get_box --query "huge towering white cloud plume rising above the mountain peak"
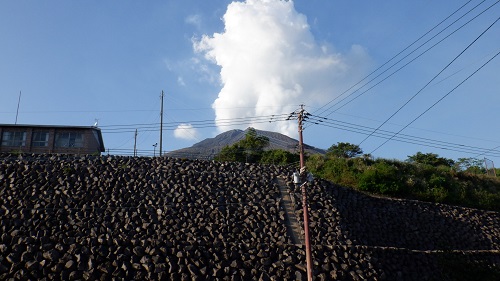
[193,0,368,136]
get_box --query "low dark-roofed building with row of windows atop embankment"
[0,124,105,154]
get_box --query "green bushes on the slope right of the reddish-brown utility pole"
[306,144,500,211]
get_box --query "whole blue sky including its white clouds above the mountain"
[0,0,500,166]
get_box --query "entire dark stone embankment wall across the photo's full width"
[0,155,500,280]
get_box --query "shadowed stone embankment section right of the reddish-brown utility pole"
[288,176,500,280]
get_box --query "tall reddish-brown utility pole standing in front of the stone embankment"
[298,105,312,281]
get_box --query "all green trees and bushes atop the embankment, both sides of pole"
[215,133,500,211]
